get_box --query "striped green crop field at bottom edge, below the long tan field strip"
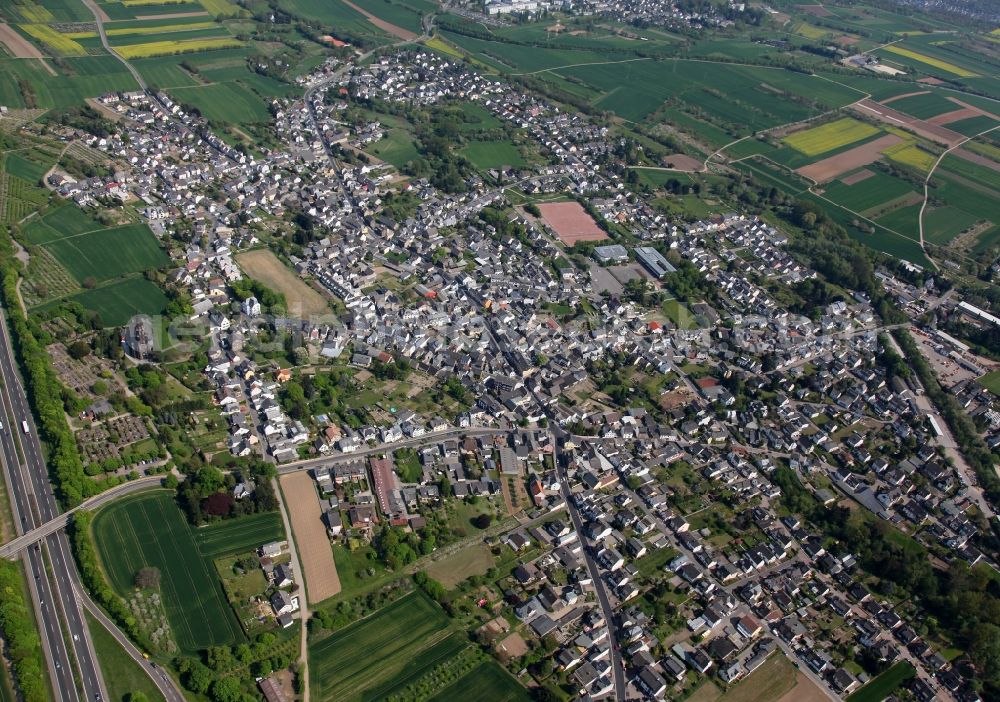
[309,592,478,702]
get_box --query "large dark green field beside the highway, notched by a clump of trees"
[93,490,243,652]
